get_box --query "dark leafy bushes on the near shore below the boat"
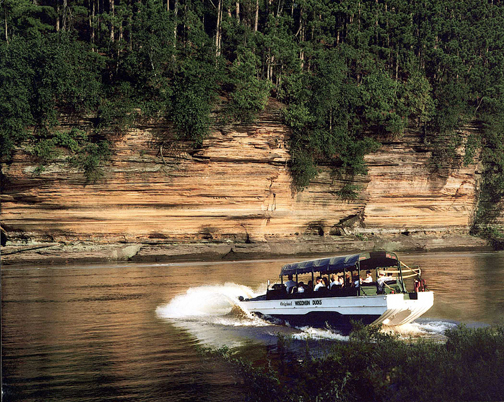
[207,326,504,402]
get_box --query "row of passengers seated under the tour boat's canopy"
[285,271,393,293]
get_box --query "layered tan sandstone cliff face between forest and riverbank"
[2,101,488,264]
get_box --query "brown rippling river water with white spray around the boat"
[2,252,504,401]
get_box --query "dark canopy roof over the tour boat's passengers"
[280,251,399,276]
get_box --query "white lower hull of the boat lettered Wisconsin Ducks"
[239,292,434,326]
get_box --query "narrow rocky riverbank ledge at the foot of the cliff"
[1,232,491,265]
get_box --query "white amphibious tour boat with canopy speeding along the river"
[238,251,434,328]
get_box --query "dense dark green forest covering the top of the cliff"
[0,0,504,236]
